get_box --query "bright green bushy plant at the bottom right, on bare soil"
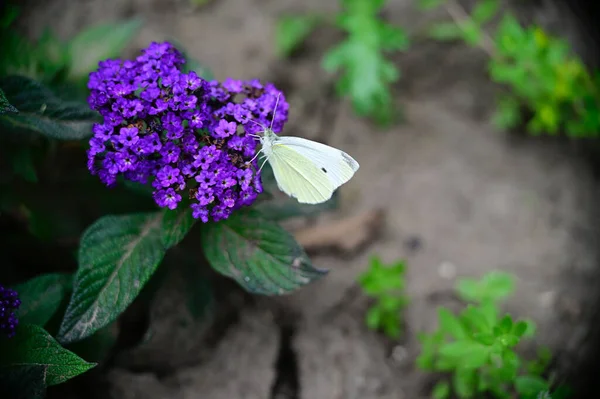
[417,273,551,399]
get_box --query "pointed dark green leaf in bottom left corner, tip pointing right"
[0,324,95,385]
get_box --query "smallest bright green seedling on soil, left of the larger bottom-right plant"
[358,257,408,339]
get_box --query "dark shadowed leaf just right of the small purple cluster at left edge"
[15,273,73,327]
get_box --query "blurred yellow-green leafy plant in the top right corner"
[420,0,600,137]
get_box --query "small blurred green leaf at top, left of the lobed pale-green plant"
[275,15,321,57]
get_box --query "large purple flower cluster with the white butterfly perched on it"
[88,42,288,223]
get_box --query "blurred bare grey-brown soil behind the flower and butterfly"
[17,0,598,399]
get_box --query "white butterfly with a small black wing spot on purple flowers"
[247,97,359,204]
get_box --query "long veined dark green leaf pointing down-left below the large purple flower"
[58,212,166,343]
